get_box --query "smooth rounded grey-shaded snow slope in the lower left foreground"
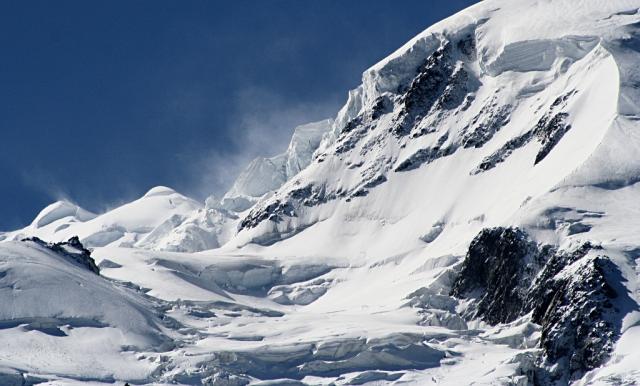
[0,241,173,385]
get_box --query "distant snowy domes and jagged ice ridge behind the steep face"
[5,119,333,252]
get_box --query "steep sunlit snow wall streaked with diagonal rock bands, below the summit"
[237,7,623,253]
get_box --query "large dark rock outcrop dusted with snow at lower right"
[451,228,619,385]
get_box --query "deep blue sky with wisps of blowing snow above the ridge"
[0,0,473,230]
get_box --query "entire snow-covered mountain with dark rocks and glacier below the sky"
[0,0,640,385]
